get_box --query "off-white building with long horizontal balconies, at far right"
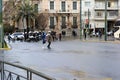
[94,0,120,31]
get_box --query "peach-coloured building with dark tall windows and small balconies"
[36,0,80,34]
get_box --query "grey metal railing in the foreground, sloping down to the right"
[0,61,55,80]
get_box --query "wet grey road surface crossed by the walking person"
[0,40,120,80]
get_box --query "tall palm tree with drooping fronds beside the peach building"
[16,0,36,39]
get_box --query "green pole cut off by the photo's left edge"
[0,0,4,48]
